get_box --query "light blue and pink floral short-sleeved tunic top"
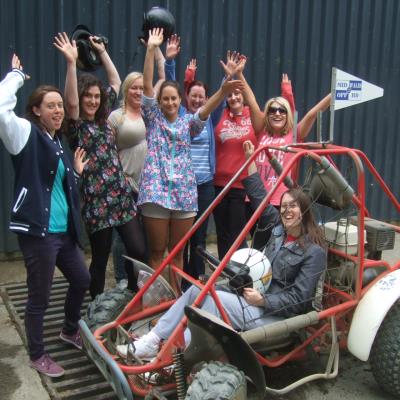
[138,96,206,211]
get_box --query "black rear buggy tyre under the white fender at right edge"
[370,300,400,398]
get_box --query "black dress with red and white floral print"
[69,87,136,234]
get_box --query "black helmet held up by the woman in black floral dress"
[71,25,108,72]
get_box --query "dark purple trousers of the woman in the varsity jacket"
[18,234,90,360]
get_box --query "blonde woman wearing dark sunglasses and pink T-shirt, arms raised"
[237,60,331,206]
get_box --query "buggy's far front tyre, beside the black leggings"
[83,287,135,332]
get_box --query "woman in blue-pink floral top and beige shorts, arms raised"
[138,29,242,293]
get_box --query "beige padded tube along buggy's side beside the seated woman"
[240,311,319,344]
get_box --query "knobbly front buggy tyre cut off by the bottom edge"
[185,361,247,400]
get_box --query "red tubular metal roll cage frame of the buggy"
[86,143,400,396]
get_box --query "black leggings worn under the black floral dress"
[89,217,146,299]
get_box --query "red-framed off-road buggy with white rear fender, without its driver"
[81,143,400,399]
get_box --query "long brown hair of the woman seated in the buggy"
[279,188,326,248]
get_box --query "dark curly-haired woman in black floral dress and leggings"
[54,33,145,298]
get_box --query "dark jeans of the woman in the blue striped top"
[182,180,215,290]
